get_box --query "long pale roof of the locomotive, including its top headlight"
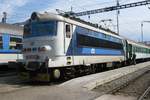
[31,12,122,39]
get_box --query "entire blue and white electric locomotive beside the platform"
[19,13,150,81]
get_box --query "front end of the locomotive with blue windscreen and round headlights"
[22,13,57,81]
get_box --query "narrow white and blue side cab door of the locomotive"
[65,23,74,64]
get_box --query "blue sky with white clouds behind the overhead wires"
[0,0,150,41]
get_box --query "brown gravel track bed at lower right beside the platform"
[94,68,150,100]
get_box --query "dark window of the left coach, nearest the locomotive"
[9,37,22,50]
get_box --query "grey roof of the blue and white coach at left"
[0,23,23,35]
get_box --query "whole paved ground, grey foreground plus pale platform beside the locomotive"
[0,62,150,100]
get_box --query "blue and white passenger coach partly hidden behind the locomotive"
[0,23,23,65]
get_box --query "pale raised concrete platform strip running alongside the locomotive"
[59,62,150,91]
